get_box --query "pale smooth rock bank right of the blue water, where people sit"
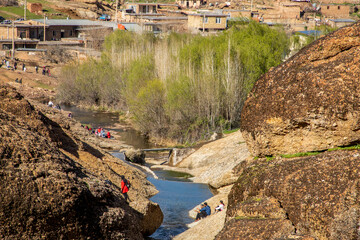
[148,131,250,240]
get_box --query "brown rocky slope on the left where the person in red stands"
[0,85,163,239]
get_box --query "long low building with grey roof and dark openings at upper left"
[0,19,121,50]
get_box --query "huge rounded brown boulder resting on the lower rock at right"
[241,23,360,156]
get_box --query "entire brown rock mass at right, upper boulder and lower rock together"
[216,23,360,240]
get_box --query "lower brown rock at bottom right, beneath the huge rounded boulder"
[216,150,360,240]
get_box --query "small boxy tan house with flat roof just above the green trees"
[188,13,229,32]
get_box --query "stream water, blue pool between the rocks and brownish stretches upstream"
[61,106,213,240]
